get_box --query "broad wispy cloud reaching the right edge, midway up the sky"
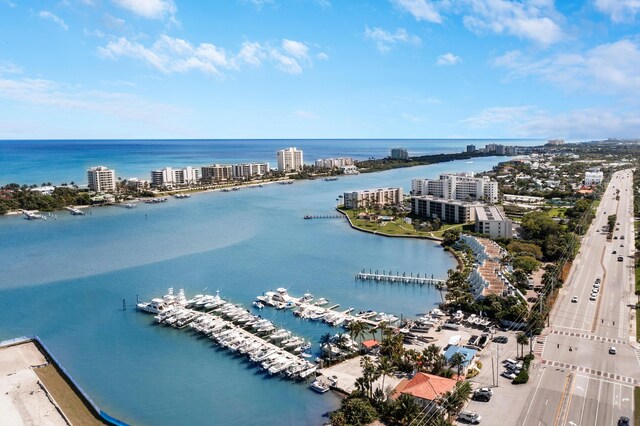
[494,39,640,95]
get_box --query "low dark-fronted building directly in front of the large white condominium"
[411,195,479,223]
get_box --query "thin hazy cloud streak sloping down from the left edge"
[0,74,178,128]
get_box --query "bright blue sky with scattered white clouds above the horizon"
[0,0,640,140]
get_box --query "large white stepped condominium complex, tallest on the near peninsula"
[411,173,498,203]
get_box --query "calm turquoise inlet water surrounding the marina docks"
[0,140,520,425]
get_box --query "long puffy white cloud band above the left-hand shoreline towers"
[98,35,320,76]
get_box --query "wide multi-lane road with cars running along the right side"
[518,171,640,426]
